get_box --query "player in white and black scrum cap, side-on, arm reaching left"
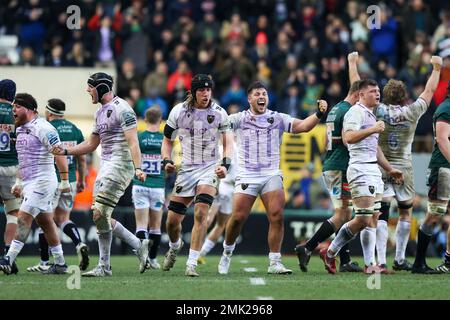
[53,72,149,277]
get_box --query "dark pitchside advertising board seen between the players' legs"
[0,208,370,255]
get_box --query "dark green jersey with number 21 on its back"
[133,131,165,188]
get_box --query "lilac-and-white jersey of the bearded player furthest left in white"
[16,117,61,182]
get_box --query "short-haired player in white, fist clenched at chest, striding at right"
[320,79,403,274]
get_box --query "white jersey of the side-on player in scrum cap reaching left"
[92,97,137,161]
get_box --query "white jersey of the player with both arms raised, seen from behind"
[374,98,428,166]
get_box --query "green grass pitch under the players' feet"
[0,255,450,300]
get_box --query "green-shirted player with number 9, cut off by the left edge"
[0,79,20,273]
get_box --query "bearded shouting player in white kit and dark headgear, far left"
[0,93,70,274]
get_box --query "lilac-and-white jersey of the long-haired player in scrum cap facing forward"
[167,102,230,169]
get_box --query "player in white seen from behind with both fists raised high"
[350,52,442,271]
